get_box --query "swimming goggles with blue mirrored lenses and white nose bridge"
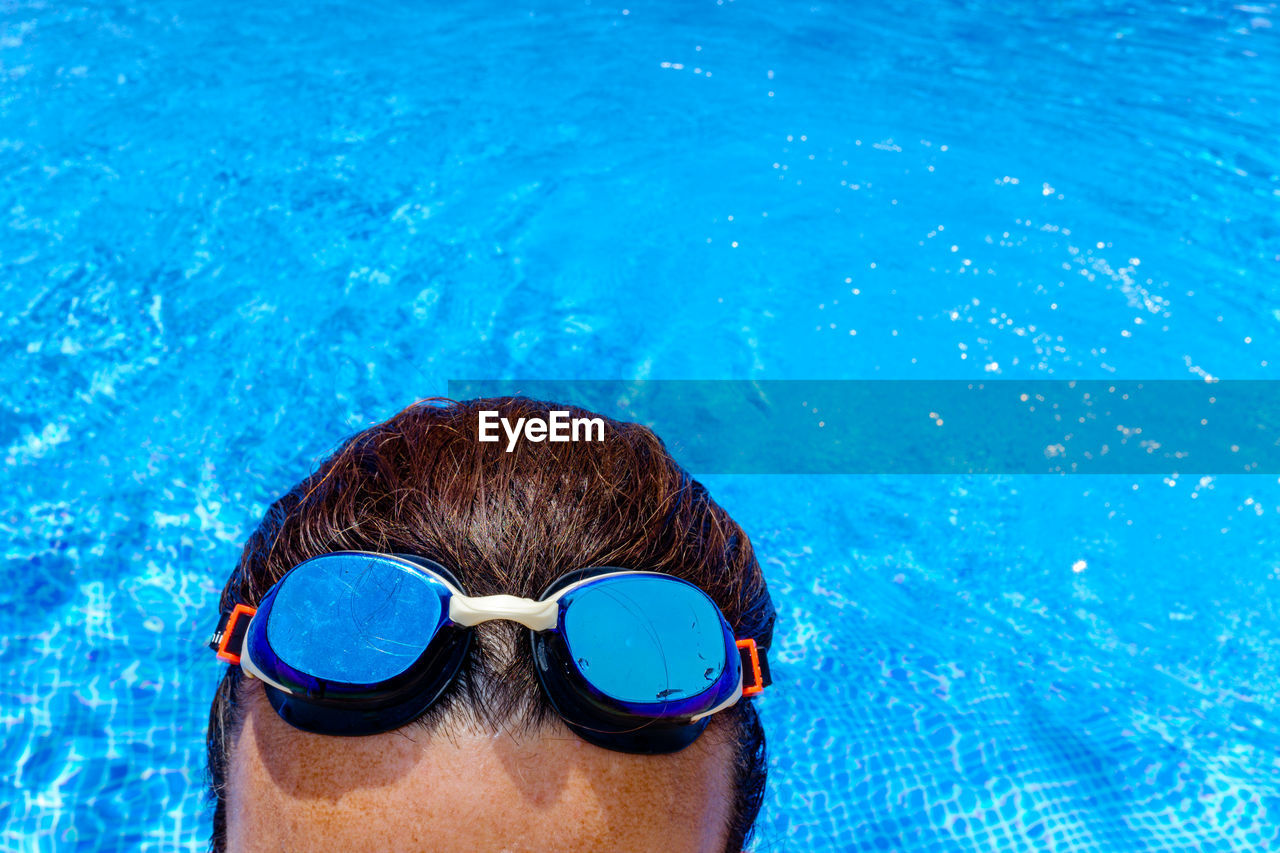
[209,551,772,753]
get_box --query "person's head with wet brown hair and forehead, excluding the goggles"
[207,398,772,853]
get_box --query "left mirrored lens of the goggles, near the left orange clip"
[266,555,442,684]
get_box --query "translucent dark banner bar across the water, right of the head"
[449,379,1280,475]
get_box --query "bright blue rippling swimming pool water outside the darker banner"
[0,0,1280,853]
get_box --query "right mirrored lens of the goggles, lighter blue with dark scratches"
[564,576,726,704]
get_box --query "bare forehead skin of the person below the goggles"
[227,681,733,853]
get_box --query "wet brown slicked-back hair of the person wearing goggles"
[206,397,772,853]
